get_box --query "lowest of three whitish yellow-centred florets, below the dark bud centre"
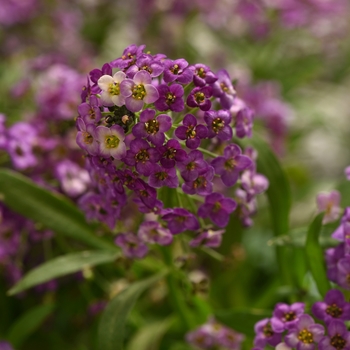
[95,125,126,159]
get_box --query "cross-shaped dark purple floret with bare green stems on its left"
[175,114,208,149]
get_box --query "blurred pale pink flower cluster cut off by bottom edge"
[186,318,244,350]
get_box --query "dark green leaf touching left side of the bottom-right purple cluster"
[215,309,272,336]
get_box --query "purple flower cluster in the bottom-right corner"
[254,289,350,350]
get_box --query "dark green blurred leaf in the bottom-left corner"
[7,304,54,349]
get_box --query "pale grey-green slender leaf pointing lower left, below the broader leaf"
[8,250,119,295]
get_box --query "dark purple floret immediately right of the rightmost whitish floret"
[154,84,185,112]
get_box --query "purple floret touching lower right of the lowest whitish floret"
[124,139,160,176]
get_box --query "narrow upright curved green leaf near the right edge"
[305,213,331,297]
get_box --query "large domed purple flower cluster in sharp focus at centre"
[76,45,268,257]
